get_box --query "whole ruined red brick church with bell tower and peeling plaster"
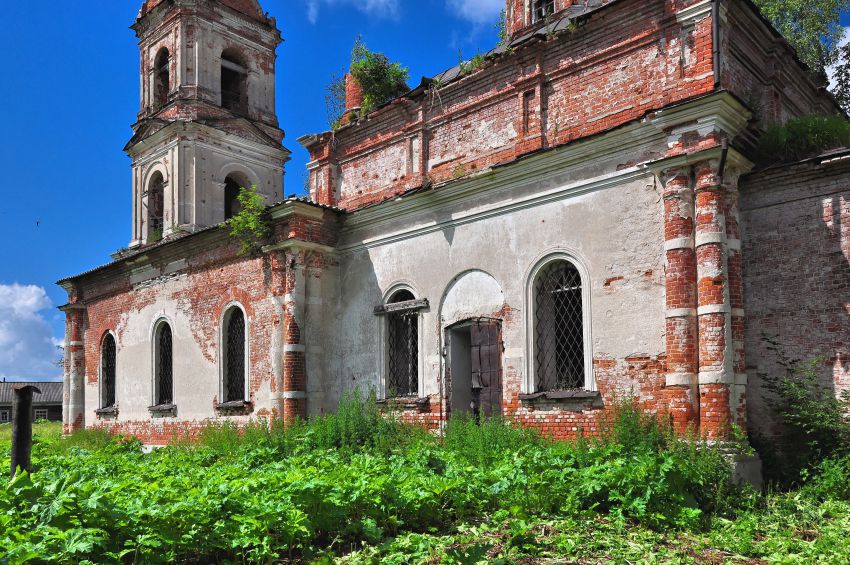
[59,0,850,454]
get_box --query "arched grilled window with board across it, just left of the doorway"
[387,290,419,397]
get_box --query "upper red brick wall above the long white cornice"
[306,0,716,209]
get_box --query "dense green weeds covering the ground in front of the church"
[0,395,850,563]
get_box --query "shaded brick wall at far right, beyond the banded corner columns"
[741,156,850,435]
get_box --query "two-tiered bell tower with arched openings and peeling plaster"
[124,0,290,247]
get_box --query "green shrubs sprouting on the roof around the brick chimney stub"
[325,37,410,130]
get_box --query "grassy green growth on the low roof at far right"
[758,116,850,164]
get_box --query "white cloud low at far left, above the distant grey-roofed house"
[0,284,62,380]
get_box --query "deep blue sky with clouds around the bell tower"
[0,0,503,380]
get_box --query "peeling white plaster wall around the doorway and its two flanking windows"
[314,163,665,409]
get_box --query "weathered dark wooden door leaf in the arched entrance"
[470,320,502,418]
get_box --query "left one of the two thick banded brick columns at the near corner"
[660,167,699,434]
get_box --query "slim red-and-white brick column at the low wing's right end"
[282,249,307,423]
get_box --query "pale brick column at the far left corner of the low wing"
[61,305,86,434]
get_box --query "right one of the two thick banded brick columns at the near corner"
[695,159,734,440]
